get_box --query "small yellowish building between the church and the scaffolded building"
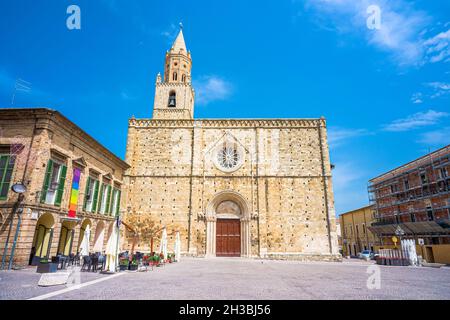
[339,205,379,256]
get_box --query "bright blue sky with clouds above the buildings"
[0,0,450,214]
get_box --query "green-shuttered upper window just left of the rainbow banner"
[41,159,67,206]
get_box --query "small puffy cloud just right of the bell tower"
[194,75,232,105]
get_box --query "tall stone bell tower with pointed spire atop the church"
[153,24,195,119]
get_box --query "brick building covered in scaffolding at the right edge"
[369,146,450,263]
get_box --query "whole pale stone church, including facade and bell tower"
[122,30,340,260]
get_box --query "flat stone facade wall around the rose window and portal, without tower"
[125,119,338,258]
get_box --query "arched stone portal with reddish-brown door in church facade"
[205,191,251,257]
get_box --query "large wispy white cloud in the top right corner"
[300,0,450,65]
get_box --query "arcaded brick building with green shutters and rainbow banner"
[0,108,129,265]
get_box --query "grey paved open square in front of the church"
[0,258,450,300]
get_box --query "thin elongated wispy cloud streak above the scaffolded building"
[384,110,449,132]
